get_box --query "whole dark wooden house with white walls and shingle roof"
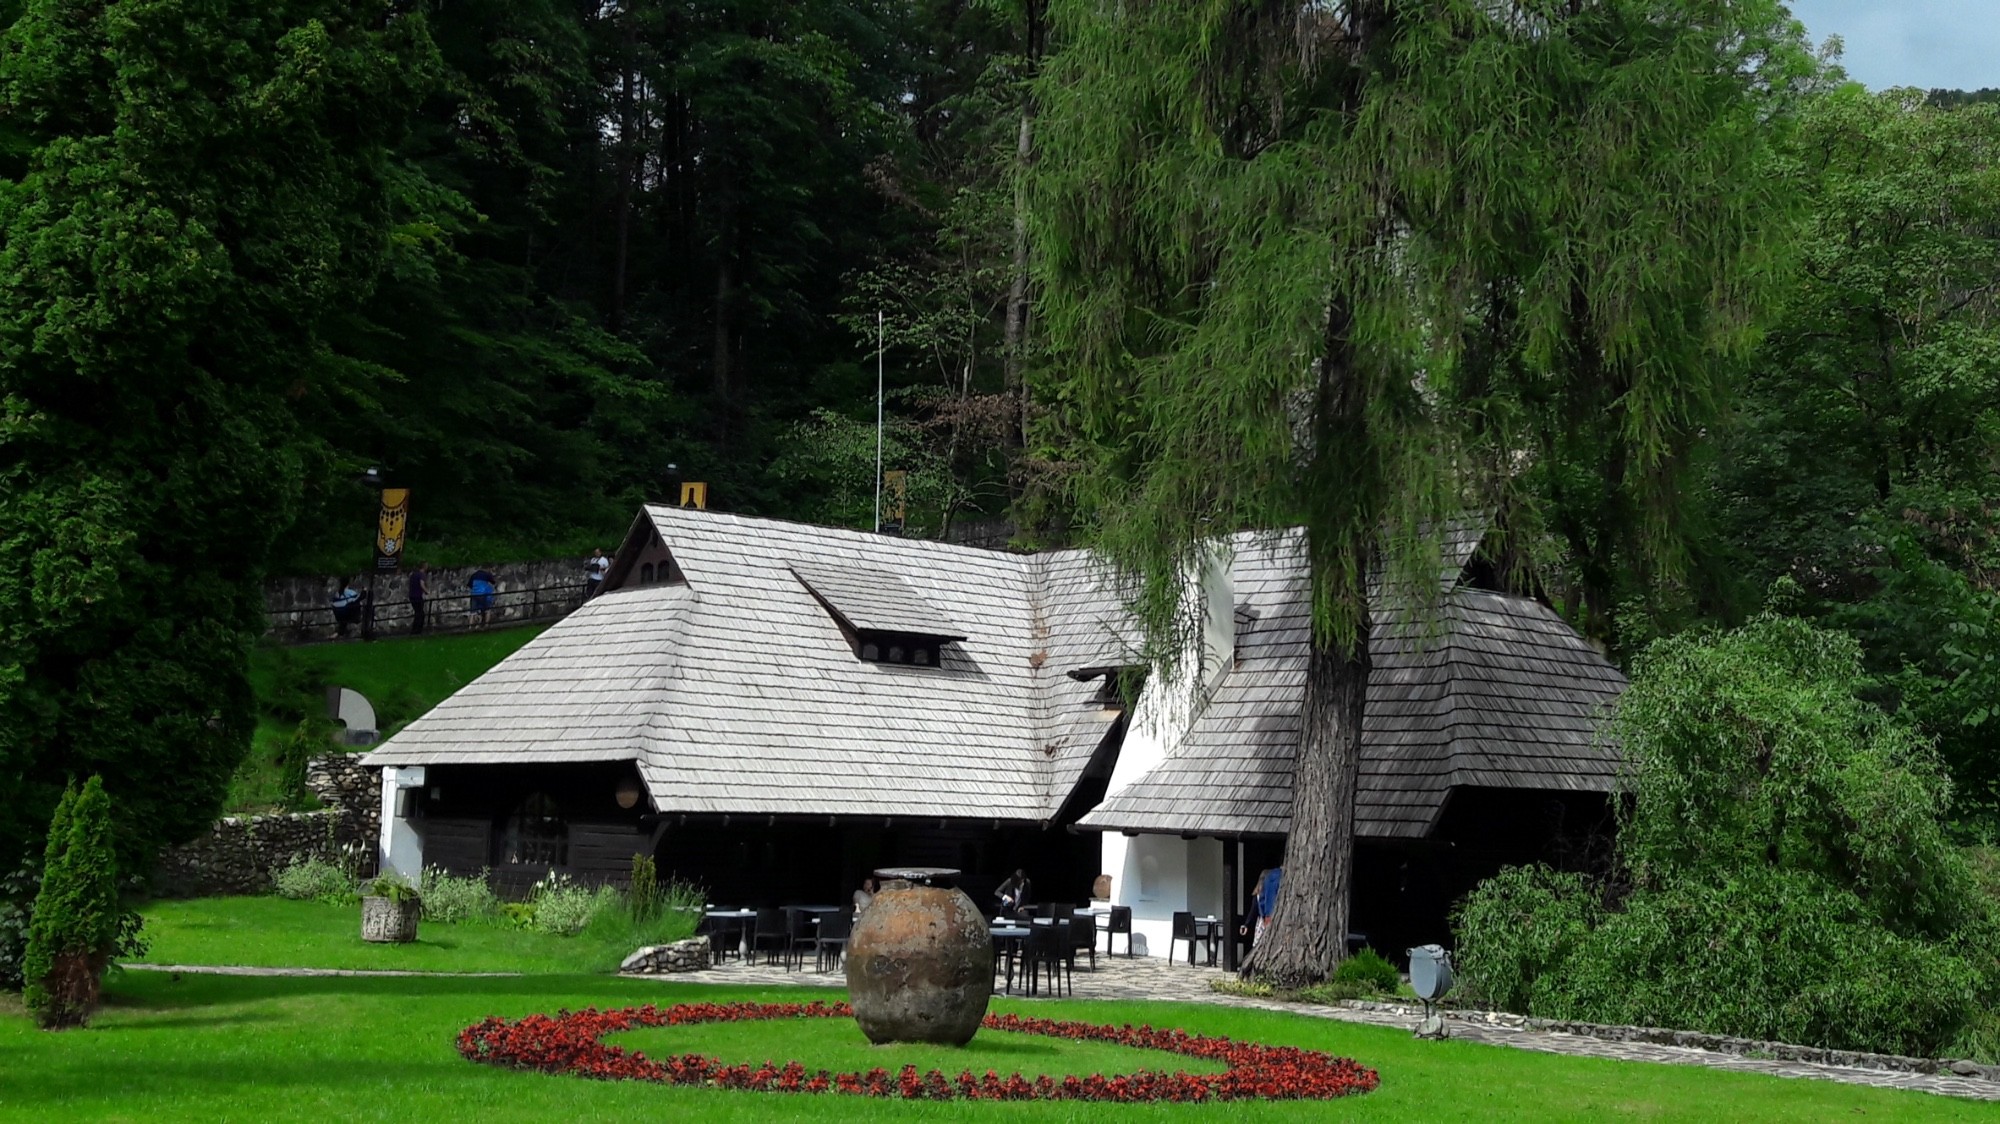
[368,506,1624,952]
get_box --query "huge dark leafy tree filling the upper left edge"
[0,0,434,870]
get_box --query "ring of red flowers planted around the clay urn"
[458,1002,1380,1100]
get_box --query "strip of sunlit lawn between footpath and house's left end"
[144,898,664,972]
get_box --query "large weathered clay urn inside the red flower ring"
[846,870,994,1046]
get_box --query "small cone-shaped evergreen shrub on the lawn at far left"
[22,776,122,1030]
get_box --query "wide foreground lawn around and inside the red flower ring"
[0,972,1994,1124]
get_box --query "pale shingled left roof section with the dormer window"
[368,506,1126,822]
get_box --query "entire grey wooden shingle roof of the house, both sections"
[368,506,1624,836]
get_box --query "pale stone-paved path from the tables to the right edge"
[642,956,2000,1102]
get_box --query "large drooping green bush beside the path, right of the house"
[1456,616,2000,1056]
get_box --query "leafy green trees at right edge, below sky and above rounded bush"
[1710,86,2000,836]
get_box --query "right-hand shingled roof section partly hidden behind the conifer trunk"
[1080,526,1626,838]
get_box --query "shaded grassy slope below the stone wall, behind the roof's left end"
[228,624,546,812]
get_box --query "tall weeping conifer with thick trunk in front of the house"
[1028,0,1810,984]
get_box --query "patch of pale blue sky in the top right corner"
[1790,0,2000,90]
